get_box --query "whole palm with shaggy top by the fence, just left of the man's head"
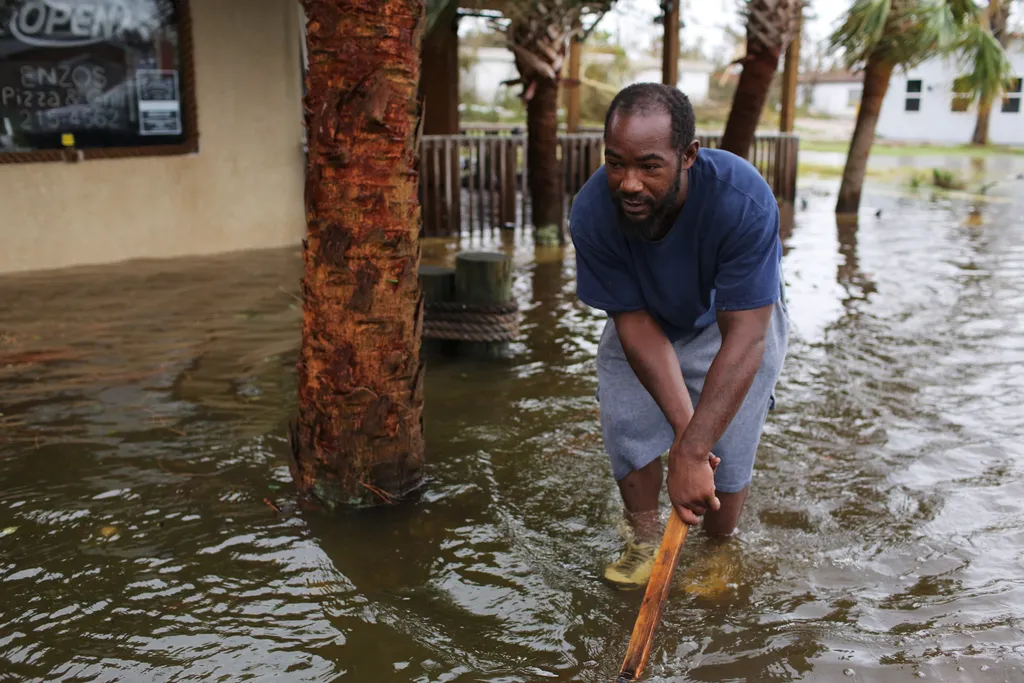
[492,0,613,244]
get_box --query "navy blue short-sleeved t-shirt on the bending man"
[569,148,782,341]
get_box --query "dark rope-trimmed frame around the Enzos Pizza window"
[0,0,199,165]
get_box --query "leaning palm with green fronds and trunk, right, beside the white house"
[830,0,1009,213]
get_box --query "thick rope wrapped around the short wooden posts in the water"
[423,301,519,342]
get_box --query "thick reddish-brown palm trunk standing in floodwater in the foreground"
[291,0,424,509]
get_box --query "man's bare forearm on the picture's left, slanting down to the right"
[613,311,693,437]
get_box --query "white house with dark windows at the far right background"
[877,42,1024,145]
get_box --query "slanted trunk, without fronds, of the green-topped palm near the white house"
[836,52,893,213]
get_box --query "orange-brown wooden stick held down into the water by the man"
[615,509,689,683]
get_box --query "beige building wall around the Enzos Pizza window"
[0,0,305,272]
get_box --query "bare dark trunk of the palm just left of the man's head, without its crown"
[526,79,565,244]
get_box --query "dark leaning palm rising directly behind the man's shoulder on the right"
[721,0,803,157]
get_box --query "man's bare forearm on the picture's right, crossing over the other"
[680,309,765,459]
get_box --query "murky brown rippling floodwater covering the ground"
[0,162,1024,683]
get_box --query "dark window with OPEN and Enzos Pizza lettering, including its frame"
[0,0,199,163]
